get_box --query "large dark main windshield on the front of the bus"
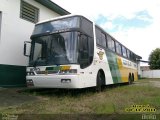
[29,32,79,66]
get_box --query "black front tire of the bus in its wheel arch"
[96,70,105,92]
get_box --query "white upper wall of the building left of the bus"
[0,0,60,66]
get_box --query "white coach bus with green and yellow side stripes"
[24,15,141,90]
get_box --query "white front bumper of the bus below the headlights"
[26,74,84,88]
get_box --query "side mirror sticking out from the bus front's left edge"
[23,41,31,57]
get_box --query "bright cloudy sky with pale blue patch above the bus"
[52,0,160,65]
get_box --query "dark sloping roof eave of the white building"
[35,0,71,15]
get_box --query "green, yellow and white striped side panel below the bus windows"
[106,51,138,83]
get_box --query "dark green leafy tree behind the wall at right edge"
[149,48,160,69]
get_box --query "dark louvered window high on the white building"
[20,0,39,23]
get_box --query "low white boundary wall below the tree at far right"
[141,70,160,78]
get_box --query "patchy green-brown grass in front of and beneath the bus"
[0,79,160,119]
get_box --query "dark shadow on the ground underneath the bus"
[19,84,126,97]
